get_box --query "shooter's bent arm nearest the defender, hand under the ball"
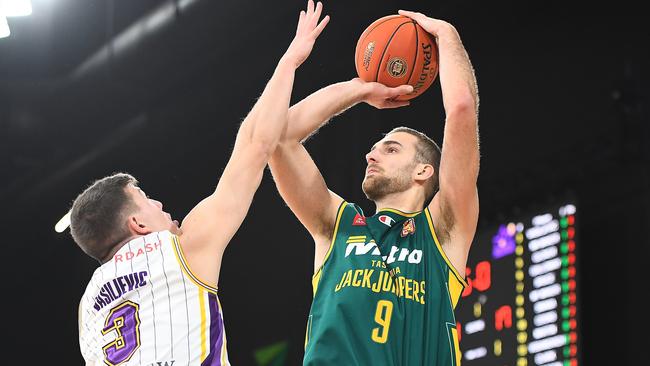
[269,79,413,269]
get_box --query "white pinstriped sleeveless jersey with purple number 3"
[79,231,230,366]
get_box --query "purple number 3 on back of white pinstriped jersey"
[102,301,140,366]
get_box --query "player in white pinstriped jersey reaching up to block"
[71,0,329,366]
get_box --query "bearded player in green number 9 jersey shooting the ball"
[269,11,479,366]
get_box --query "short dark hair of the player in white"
[70,173,138,262]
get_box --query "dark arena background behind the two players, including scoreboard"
[0,0,650,366]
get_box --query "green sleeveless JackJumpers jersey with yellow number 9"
[303,202,467,366]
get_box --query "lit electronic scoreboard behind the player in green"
[455,203,580,366]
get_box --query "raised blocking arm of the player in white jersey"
[181,0,329,285]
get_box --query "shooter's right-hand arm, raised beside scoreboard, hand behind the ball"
[400,11,480,273]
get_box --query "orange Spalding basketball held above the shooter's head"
[354,15,438,100]
